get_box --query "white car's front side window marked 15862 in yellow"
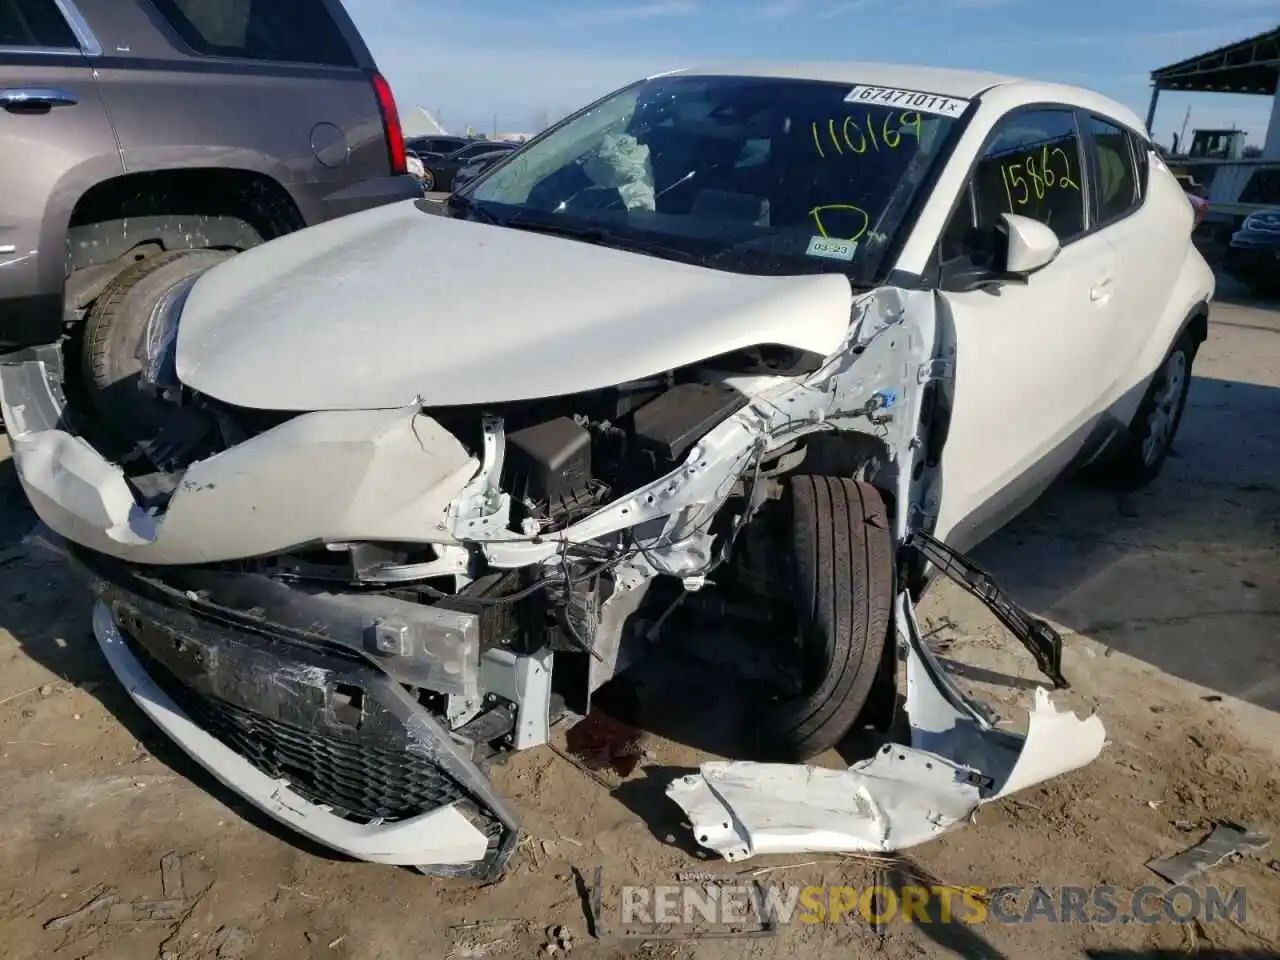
[973,108,1085,243]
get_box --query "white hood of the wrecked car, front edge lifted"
[175,201,852,411]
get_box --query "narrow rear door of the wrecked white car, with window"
[1082,114,1194,416]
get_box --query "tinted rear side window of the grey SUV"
[151,0,356,67]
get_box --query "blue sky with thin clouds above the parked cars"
[344,0,1280,143]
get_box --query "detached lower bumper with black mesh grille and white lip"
[85,568,518,881]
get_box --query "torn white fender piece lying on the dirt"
[667,596,1106,863]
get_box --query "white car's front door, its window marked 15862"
[936,105,1117,549]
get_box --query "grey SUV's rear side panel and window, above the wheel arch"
[81,0,392,223]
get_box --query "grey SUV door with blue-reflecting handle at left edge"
[0,0,122,349]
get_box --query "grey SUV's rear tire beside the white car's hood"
[81,250,232,455]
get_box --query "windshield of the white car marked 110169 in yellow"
[458,76,956,283]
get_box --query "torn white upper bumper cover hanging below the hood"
[0,350,477,564]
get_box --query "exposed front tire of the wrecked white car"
[763,475,893,760]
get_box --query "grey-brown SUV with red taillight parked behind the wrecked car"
[0,0,421,435]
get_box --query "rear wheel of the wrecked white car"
[1102,330,1198,490]
